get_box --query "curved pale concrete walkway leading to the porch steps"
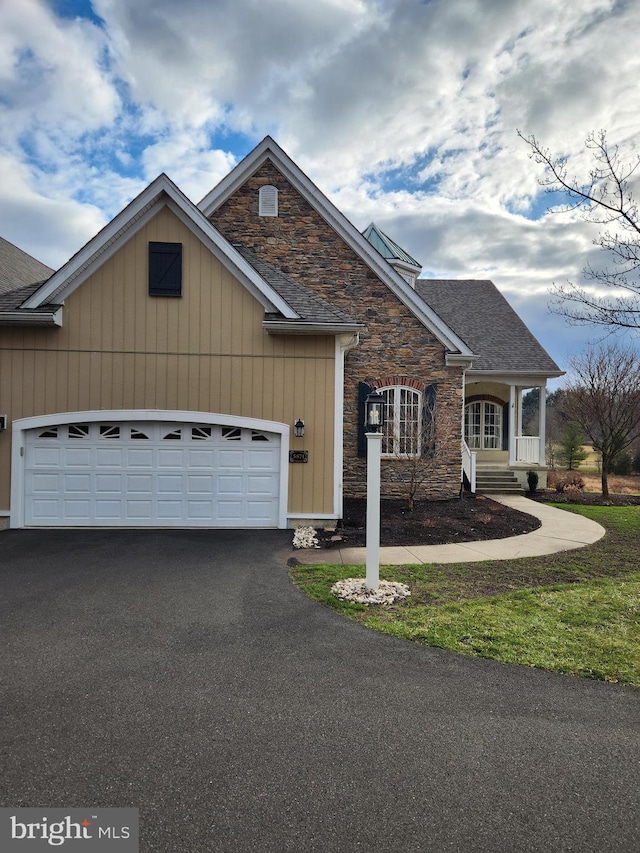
[292,494,605,566]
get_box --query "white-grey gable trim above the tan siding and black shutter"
[22,173,298,320]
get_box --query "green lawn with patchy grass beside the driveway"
[291,504,640,687]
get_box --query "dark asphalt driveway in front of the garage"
[0,531,640,853]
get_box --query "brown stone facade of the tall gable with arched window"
[210,161,463,498]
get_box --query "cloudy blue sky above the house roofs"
[0,0,640,366]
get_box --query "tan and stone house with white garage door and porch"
[0,137,561,528]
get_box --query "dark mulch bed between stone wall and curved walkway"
[318,494,540,548]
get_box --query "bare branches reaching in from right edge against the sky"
[518,130,640,331]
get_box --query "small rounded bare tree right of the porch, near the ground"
[562,344,640,498]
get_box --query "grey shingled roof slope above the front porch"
[416,278,563,377]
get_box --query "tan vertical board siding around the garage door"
[0,208,335,514]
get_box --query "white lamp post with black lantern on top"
[364,391,385,589]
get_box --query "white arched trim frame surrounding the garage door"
[10,409,289,528]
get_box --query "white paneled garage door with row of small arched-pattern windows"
[25,422,280,527]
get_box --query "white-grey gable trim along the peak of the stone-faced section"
[198,136,473,358]
